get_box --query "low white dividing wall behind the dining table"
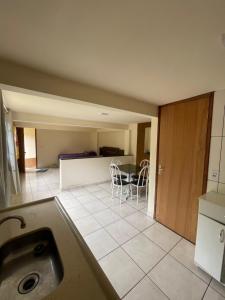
[59,156,133,189]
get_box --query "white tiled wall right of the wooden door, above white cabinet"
[207,90,225,194]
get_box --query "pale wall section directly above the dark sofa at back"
[98,130,125,150]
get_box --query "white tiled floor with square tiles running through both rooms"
[12,169,225,300]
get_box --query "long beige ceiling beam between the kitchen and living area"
[0,59,158,116]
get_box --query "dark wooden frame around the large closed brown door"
[153,92,214,219]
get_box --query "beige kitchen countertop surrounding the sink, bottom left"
[0,197,119,300]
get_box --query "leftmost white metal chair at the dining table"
[110,163,130,204]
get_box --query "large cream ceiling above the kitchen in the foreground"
[0,0,225,104]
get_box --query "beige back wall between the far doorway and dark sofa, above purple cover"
[37,129,97,168]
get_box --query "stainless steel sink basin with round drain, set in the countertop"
[0,229,63,300]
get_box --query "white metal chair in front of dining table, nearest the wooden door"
[130,166,149,204]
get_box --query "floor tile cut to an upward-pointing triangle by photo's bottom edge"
[123,277,168,300]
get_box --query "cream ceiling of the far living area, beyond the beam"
[3,91,150,124]
